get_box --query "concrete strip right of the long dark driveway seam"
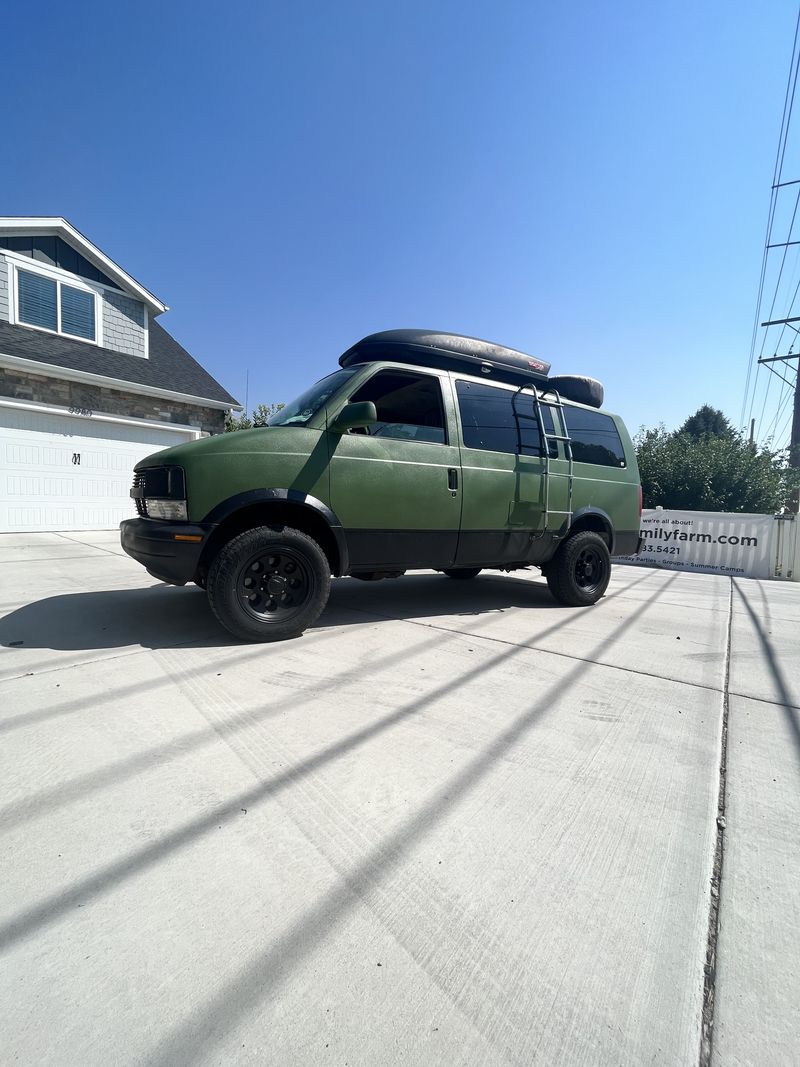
[714,580,800,1067]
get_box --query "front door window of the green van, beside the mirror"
[350,370,447,445]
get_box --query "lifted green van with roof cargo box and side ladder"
[121,330,641,641]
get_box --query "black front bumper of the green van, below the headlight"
[119,519,214,586]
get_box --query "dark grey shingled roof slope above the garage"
[0,319,239,409]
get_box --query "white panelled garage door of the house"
[0,404,197,532]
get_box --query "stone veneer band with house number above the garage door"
[0,367,225,433]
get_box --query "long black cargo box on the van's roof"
[339,330,550,388]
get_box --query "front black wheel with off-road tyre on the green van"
[207,526,331,641]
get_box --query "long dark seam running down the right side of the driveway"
[698,578,734,1067]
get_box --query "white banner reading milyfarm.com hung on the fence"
[615,509,774,578]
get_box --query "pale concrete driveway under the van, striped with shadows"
[0,534,800,1067]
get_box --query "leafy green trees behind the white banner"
[635,420,795,514]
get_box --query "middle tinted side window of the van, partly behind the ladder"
[455,382,555,456]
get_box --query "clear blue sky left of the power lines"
[0,0,800,441]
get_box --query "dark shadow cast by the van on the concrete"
[0,574,566,652]
